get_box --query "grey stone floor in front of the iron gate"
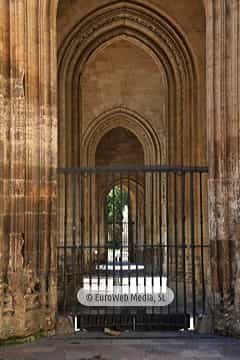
[0,333,240,360]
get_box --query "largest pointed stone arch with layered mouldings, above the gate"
[58,2,200,165]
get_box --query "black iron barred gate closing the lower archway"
[57,166,209,329]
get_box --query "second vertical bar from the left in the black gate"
[71,174,77,309]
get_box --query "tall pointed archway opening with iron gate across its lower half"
[58,2,210,328]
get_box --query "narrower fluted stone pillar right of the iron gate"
[205,0,240,334]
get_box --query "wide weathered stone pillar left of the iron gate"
[0,0,57,338]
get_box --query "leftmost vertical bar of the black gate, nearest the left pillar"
[63,174,68,313]
